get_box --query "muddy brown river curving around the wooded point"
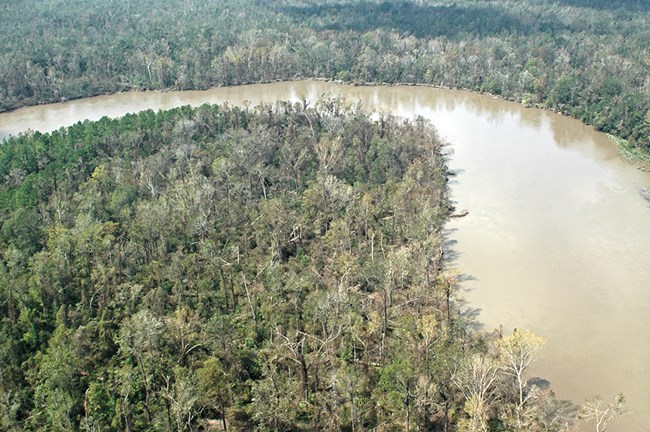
[0,81,650,432]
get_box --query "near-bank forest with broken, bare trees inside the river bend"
[0,103,572,432]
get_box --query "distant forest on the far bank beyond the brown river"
[0,0,650,151]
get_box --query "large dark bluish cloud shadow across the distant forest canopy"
[279,1,564,37]
